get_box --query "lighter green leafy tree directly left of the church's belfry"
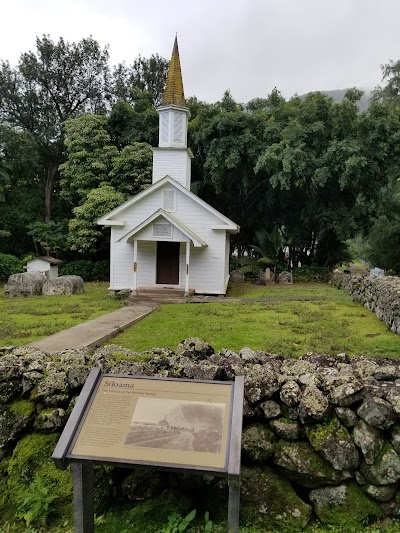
[60,115,153,255]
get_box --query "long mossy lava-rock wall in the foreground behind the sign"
[0,338,400,531]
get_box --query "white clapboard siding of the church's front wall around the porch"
[110,184,236,294]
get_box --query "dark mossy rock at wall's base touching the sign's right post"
[240,466,312,533]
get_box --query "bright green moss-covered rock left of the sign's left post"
[7,433,72,523]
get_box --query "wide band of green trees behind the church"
[0,35,400,270]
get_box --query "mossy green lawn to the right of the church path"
[110,284,400,357]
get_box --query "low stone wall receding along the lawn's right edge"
[331,272,400,335]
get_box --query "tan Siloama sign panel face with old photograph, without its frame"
[67,376,232,469]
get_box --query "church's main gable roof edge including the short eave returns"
[97,176,240,233]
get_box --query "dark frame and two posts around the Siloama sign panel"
[52,368,244,533]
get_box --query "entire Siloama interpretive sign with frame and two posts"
[53,369,244,533]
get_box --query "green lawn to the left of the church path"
[0,282,123,346]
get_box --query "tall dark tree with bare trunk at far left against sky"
[0,35,109,222]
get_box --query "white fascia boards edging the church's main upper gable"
[97,175,240,227]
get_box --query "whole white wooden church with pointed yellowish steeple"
[98,38,240,295]
